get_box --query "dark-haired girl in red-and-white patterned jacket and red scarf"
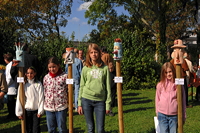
[43,57,68,133]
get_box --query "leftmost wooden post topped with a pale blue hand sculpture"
[13,43,26,133]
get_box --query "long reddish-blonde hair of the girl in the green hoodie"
[85,43,103,67]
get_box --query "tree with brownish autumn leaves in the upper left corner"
[0,0,73,39]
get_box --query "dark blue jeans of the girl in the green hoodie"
[81,98,106,133]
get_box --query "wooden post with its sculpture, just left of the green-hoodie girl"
[64,48,74,133]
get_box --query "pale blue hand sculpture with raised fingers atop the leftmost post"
[14,42,25,67]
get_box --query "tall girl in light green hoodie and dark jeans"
[78,44,111,133]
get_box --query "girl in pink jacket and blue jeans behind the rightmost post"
[155,62,186,133]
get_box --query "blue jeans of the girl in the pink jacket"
[158,112,178,133]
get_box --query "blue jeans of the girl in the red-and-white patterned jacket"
[46,108,67,133]
